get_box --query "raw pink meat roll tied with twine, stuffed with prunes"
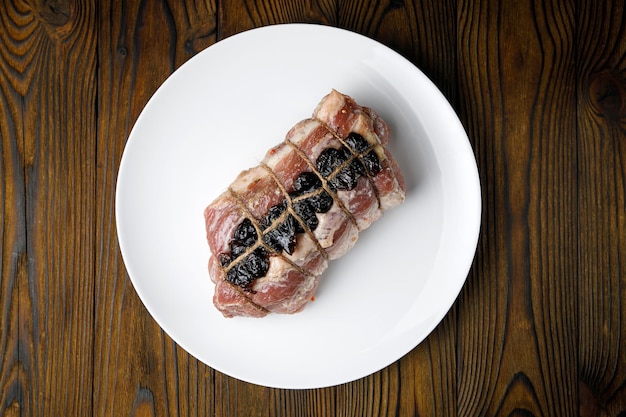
[204,90,405,317]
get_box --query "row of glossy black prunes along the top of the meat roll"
[218,132,382,291]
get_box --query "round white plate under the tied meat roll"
[116,24,481,388]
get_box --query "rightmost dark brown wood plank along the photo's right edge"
[577,1,626,416]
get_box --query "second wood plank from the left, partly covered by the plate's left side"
[93,0,216,416]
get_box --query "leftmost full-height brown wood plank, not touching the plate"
[0,2,97,416]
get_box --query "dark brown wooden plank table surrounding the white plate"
[0,0,626,417]
